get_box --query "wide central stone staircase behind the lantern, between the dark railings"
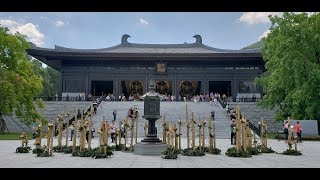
[93,101,230,139]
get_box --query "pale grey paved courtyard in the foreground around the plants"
[0,138,320,168]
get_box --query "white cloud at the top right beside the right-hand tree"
[239,12,283,25]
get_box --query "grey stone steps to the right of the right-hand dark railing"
[229,102,283,132]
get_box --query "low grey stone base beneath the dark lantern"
[133,142,168,156]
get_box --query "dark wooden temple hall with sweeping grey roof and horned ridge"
[27,34,265,97]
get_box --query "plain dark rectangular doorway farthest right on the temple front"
[209,81,231,96]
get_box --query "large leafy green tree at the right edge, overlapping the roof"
[256,13,320,121]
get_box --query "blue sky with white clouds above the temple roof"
[0,12,282,49]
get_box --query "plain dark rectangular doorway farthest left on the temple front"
[91,81,113,96]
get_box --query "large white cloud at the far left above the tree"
[0,19,44,46]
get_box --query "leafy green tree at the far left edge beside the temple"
[0,27,45,125]
